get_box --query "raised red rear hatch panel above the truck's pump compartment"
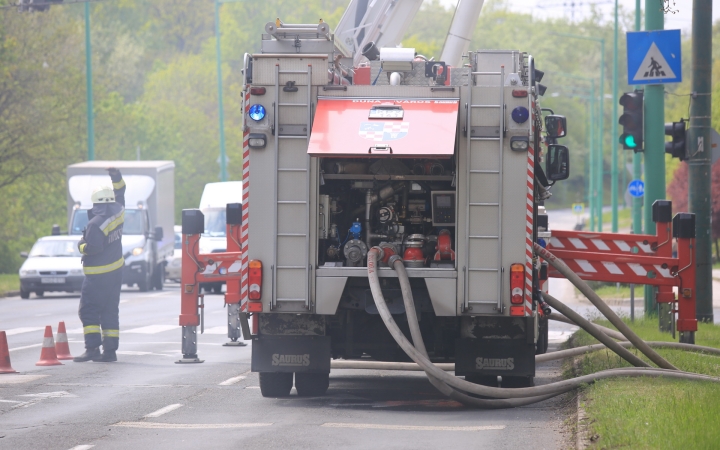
[308,98,459,158]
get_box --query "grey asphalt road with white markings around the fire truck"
[0,286,569,450]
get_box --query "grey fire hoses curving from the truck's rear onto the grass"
[358,247,720,409]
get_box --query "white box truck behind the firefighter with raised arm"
[67,161,175,292]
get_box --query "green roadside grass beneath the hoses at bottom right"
[568,319,720,449]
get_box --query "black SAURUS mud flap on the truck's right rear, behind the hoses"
[455,338,535,377]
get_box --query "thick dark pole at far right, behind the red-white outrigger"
[687,0,713,323]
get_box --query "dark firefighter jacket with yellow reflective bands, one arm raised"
[78,177,125,275]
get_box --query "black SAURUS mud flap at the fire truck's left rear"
[251,336,330,373]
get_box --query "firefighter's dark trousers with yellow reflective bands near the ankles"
[79,268,122,351]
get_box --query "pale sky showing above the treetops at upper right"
[441,0,720,34]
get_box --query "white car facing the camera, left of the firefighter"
[20,236,85,299]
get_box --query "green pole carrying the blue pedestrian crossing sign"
[644,0,670,317]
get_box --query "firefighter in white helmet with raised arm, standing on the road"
[73,168,125,362]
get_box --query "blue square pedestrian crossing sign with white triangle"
[627,30,682,85]
